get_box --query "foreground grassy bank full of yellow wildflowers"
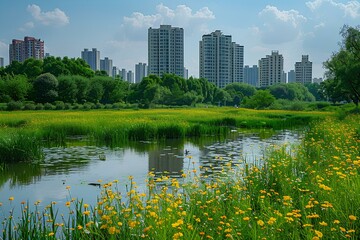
[0,113,360,240]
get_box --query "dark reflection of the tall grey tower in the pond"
[149,140,184,177]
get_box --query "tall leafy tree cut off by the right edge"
[324,25,360,108]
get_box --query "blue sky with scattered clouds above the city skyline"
[0,0,360,77]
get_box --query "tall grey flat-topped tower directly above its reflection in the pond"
[148,25,184,77]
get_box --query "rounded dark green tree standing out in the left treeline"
[33,73,59,103]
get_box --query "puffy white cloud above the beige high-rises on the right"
[256,5,307,44]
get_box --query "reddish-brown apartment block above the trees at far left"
[9,37,44,64]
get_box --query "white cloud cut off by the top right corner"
[306,0,360,18]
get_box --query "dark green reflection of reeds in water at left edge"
[0,163,42,187]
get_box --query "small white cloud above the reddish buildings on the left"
[27,4,70,26]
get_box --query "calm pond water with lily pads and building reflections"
[0,130,301,222]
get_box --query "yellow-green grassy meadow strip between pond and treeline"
[0,108,329,162]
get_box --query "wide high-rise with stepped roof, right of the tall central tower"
[199,30,244,87]
